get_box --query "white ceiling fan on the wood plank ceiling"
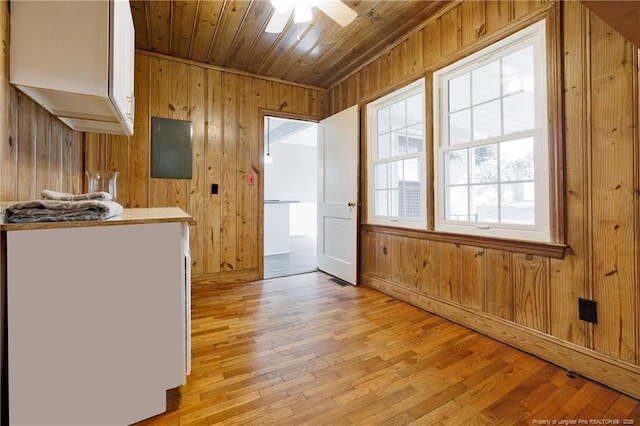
[265,0,358,33]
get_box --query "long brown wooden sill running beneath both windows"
[360,224,567,259]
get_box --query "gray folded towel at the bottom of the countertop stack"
[6,200,123,223]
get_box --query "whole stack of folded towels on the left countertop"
[5,189,123,223]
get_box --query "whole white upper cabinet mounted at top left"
[10,0,135,135]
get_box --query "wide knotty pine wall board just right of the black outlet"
[590,16,638,362]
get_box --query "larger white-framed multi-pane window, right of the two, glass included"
[433,21,551,242]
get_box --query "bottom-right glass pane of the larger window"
[500,182,535,225]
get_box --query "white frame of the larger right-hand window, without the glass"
[428,19,556,243]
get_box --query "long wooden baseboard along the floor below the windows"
[360,272,640,399]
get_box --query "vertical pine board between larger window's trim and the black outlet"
[549,2,591,346]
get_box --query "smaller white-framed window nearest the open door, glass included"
[367,79,426,229]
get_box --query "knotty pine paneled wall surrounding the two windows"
[329,1,640,397]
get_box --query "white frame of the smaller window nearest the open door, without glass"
[366,77,431,230]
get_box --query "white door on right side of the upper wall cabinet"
[110,0,135,132]
